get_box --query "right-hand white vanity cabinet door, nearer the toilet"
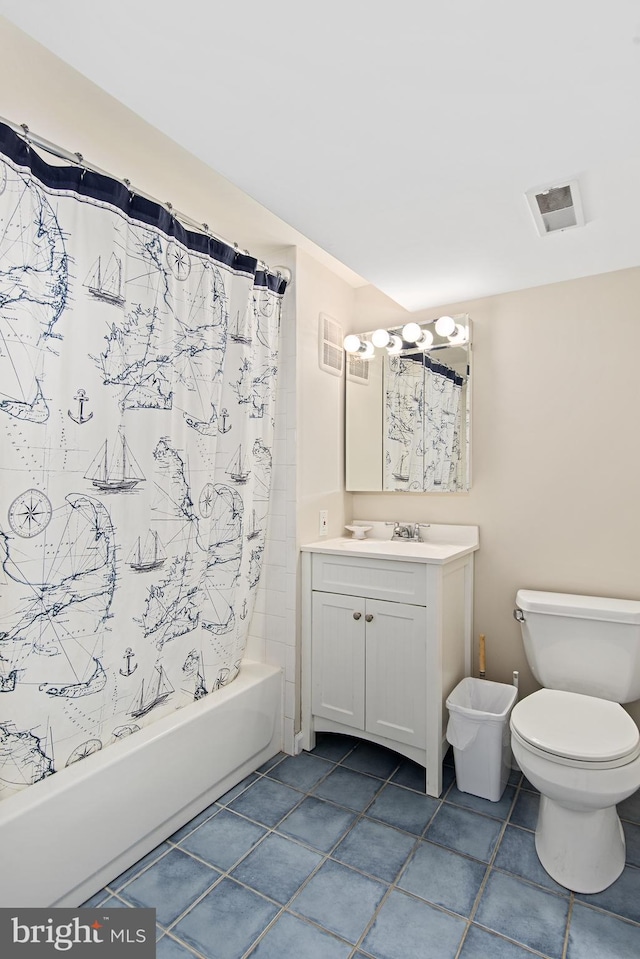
[366,599,427,749]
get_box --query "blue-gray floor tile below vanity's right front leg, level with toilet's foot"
[398,840,487,917]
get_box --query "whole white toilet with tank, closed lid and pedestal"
[510,589,640,893]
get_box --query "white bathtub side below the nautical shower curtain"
[0,662,282,908]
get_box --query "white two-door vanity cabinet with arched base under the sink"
[302,527,477,796]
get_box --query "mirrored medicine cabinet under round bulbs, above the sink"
[345,314,471,493]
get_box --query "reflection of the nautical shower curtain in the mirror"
[383,353,464,493]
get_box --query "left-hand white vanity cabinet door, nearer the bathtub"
[311,592,364,729]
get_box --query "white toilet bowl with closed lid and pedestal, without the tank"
[510,689,640,893]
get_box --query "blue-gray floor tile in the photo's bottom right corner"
[567,903,640,959]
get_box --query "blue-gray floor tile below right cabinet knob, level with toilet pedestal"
[333,819,415,882]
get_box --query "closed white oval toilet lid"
[511,689,640,762]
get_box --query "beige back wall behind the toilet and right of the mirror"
[353,268,640,719]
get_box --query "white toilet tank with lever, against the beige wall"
[514,589,640,703]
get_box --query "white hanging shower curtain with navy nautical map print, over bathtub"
[0,124,284,797]
